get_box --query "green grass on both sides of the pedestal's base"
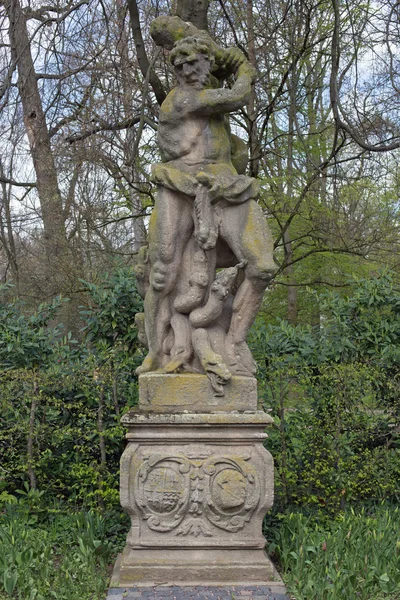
[0,496,400,600]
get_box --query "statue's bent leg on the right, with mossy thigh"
[220,200,276,375]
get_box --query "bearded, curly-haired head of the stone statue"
[170,33,215,89]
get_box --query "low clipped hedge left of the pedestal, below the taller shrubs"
[0,357,123,505]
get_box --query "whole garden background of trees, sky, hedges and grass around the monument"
[0,0,400,600]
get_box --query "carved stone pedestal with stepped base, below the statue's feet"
[111,374,278,587]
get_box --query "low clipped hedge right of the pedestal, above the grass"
[266,364,400,512]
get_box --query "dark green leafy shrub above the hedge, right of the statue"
[253,272,400,368]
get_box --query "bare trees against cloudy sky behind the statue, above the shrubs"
[0,0,400,323]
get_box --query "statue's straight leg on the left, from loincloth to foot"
[136,186,193,374]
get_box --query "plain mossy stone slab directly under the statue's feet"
[139,372,257,413]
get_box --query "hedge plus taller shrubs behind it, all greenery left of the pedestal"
[0,269,141,509]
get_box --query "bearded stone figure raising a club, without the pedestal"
[136,17,275,396]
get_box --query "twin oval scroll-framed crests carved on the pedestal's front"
[135,454,260,537]
